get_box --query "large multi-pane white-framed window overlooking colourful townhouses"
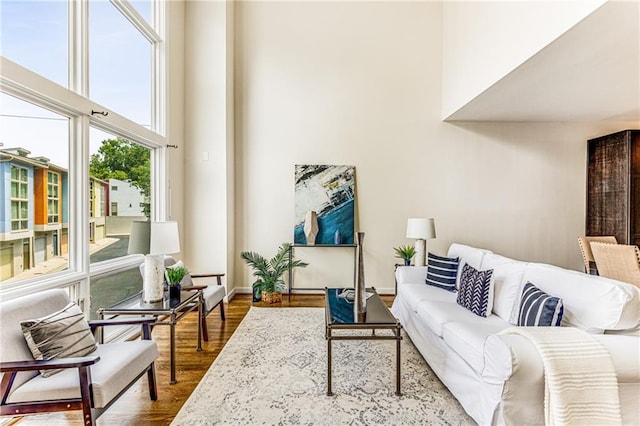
[0,0,167,312]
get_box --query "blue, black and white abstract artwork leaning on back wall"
[293,165,356,245]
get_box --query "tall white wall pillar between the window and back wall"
[182,1,234,292]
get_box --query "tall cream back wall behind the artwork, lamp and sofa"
[185,2,626,289]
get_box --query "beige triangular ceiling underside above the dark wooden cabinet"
[446,0,640,122]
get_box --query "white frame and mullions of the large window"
[0,0,168,314]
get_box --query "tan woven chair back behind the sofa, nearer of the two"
[591,242,640,287]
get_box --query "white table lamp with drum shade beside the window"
[127,221,180,303]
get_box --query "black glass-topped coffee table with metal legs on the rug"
[324,288,402,396]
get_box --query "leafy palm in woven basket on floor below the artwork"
[240,243,308,303]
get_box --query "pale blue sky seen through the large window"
[0,0,151,168]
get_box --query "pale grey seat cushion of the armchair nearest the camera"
[9,340,158,408]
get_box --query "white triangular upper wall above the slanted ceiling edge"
[442,0,606,118]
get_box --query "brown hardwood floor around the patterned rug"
[12,294,394,426]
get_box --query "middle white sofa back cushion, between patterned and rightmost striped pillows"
[482,253,527,324]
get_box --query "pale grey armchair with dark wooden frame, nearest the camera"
[0,289,158,425]
